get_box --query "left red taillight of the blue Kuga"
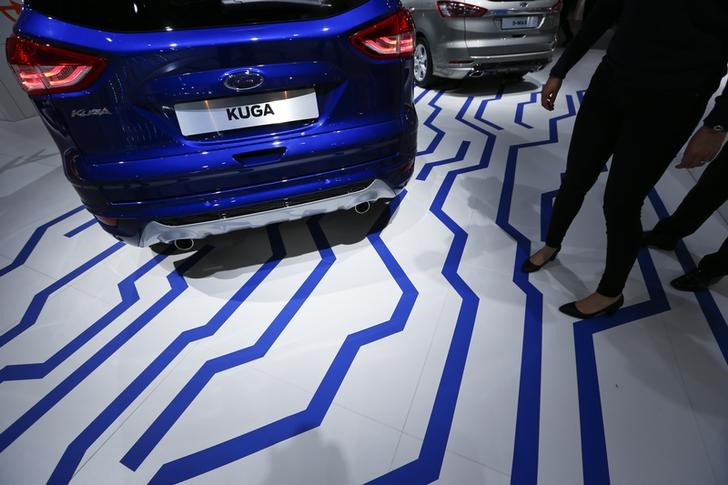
[5,35,106,94]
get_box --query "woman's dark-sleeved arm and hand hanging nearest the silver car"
[541,0,623,111]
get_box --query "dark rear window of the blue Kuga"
[25,0,366,32]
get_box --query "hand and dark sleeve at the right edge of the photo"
[677,85,728,168]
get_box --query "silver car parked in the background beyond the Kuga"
[402,0,561,87]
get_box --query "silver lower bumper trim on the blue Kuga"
[139,179,400,247]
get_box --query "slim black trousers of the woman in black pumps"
[546,62,717,297]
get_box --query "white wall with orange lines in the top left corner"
[0,0,36,121]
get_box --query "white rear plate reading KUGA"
[174,89,319,136]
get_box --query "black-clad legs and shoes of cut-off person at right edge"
[644,145,728,291]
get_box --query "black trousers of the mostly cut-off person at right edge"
[653,145,728,278]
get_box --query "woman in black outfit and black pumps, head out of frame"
[522,0,728,318]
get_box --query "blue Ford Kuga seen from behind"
[6,0,417,246]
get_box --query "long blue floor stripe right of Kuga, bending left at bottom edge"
[371,93,500,484]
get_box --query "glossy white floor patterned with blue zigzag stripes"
[0,52,728,485]
